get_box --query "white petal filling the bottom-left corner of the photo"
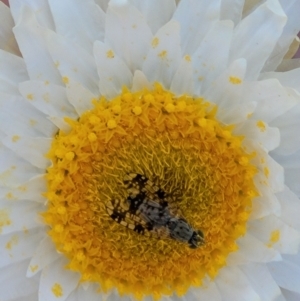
[0,260,39,301]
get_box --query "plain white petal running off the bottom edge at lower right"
[240,263,285,301]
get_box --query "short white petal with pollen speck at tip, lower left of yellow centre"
[26,235,61,277]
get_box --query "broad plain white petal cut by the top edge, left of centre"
[49,0,105,54]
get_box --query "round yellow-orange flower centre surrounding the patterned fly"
[43,84,257,299]
